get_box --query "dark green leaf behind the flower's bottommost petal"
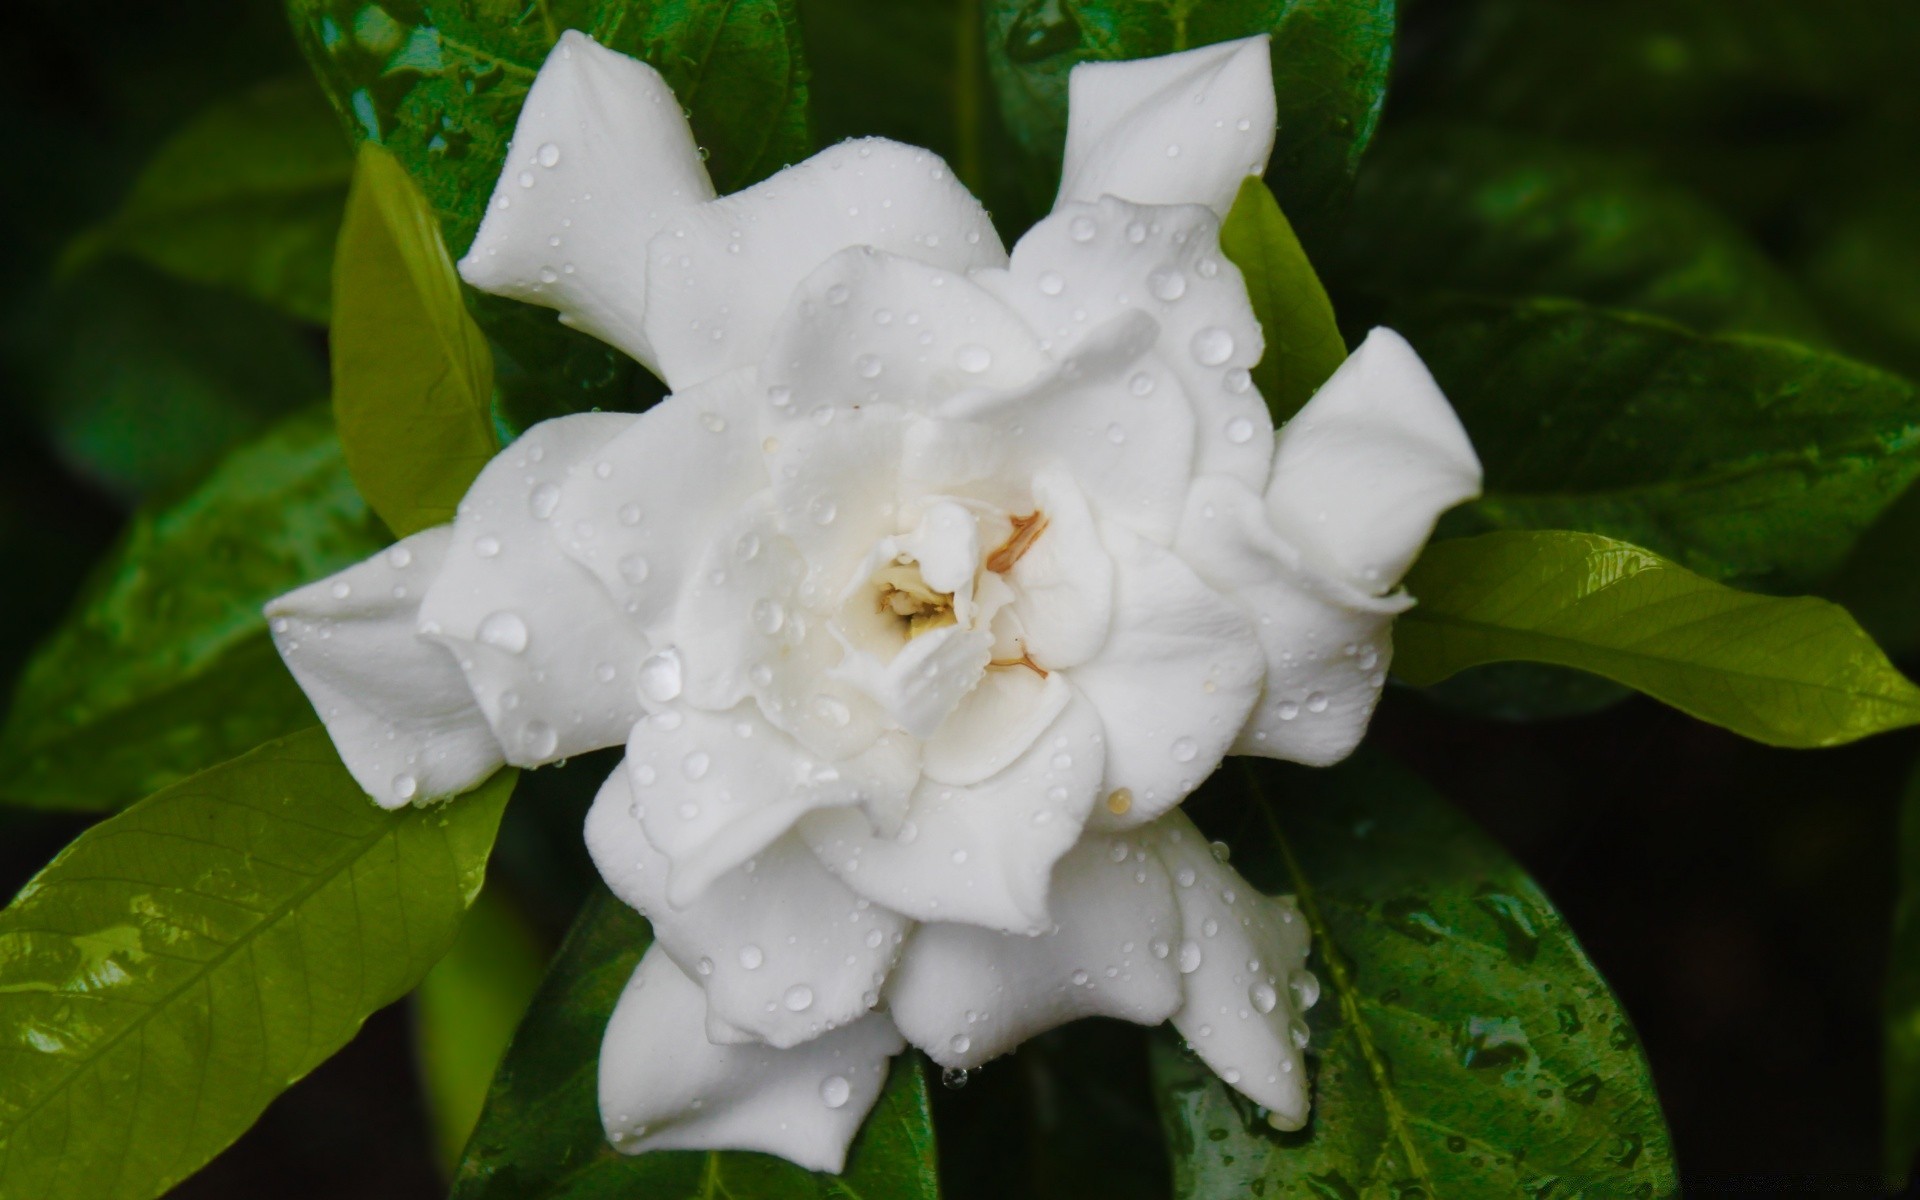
[453,887,939,1200]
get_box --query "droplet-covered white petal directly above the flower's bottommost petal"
[586,768,908,1046]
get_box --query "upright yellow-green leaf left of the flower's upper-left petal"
[332,143,499,538]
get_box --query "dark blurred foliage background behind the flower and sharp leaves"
[0,0,1920,1200]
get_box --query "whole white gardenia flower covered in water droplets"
[269,33,1480,1169]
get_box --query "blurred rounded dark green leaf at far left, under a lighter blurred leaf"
[8,259,326,497]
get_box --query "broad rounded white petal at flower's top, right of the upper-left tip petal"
[647,138,1006,388]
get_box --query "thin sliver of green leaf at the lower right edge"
[1882,752,1920,1192]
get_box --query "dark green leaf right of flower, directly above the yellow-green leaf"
[1392,298,1920,591]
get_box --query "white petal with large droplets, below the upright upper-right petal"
[1000,196,1273,499]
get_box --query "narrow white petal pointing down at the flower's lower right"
[1156,812,1319,1129]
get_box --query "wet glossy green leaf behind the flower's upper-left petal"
[288,0,810,424]
